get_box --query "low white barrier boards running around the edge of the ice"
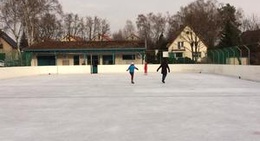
[0,64,260,81]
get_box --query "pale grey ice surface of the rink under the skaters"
[0,72,260,141]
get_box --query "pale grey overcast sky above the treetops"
[59,0,260,32]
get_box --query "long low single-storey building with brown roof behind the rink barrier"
[24,41,145,66]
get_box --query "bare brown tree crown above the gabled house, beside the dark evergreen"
[172,0,222,47]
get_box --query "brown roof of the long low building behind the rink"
[24,41,145,51]
